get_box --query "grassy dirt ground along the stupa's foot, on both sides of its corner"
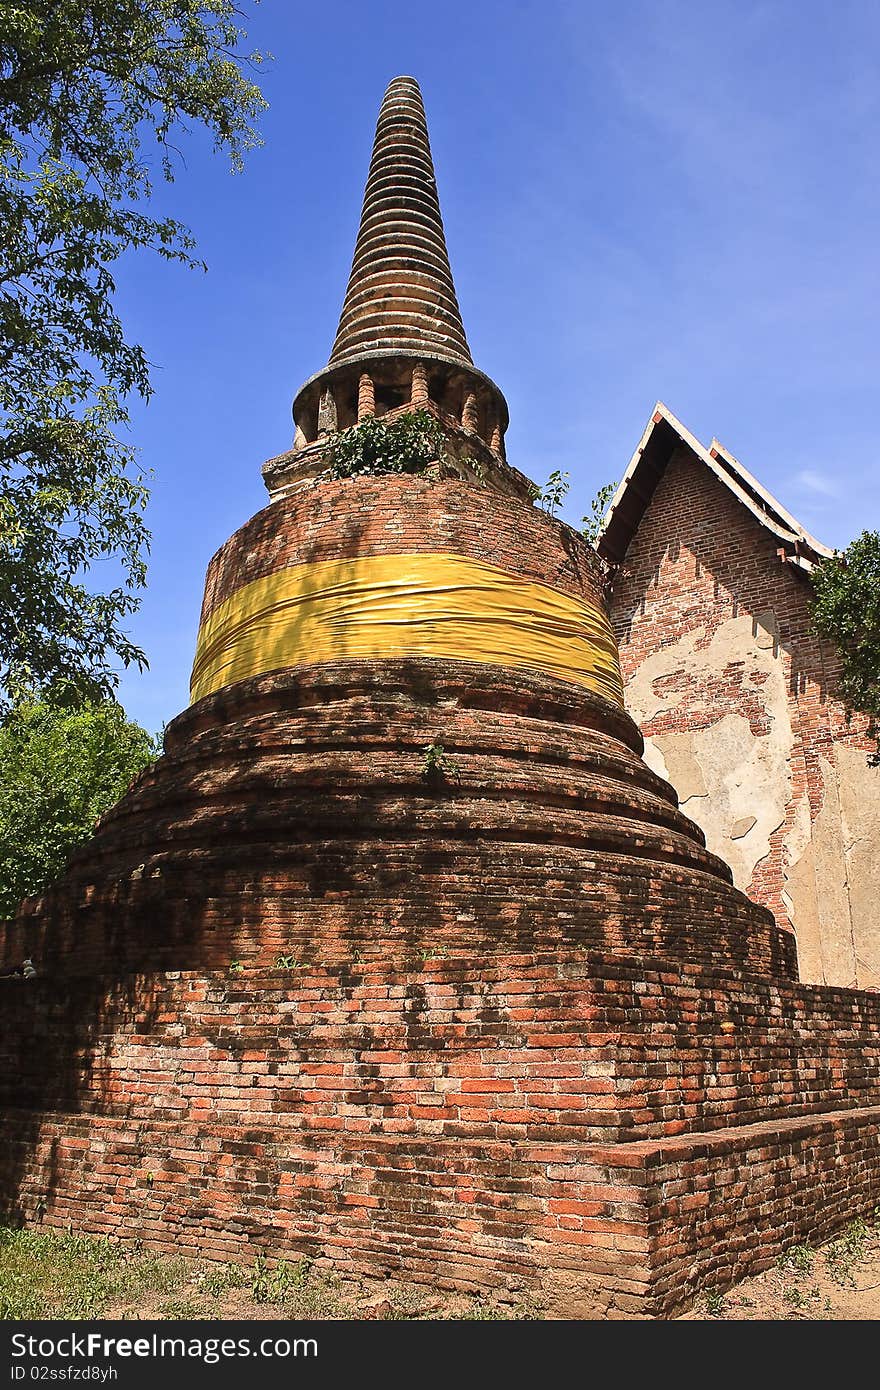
[0,1212,880,1322]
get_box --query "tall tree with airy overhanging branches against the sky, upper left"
[0,0,264,699]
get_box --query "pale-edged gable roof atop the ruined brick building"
[596,400,834,574]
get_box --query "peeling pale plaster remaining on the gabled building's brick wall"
[626,613,880,988]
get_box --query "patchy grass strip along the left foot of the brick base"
[0,1226,541,1321]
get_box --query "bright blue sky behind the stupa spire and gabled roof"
[109,0,880,728]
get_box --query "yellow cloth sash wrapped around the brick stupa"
[190,552,623,705]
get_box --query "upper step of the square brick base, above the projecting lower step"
[0,945,880,1143]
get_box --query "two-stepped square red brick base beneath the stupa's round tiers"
[0,948,880,1316]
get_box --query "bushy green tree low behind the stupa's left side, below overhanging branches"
[0,701,158,917]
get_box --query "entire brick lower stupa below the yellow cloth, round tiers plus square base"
[0,650,880,1316]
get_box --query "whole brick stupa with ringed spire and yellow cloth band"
[0,78,880,1316]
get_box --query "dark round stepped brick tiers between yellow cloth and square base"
[4,662,795,977]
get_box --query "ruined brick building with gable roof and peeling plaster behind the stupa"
[599,404,880,988]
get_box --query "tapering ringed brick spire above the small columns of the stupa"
[329,76,473,366]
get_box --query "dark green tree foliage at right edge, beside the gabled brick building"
[812,531,880,767]
